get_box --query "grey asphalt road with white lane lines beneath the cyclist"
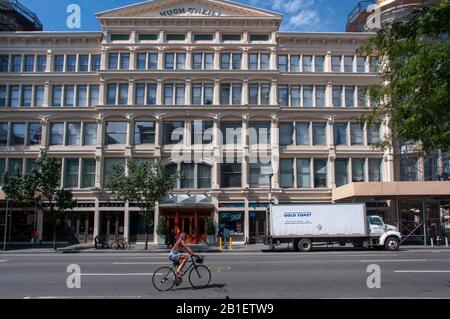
[0,249,450,299]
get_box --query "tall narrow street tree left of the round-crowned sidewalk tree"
[34,152,74,250]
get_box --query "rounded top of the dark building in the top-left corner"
[0,0,42,31]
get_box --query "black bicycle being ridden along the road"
[152,256,211,291]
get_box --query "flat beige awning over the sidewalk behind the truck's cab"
[333,181,450,202]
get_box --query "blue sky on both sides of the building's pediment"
[20,0,359,32]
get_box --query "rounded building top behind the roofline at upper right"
[347,0,438,32]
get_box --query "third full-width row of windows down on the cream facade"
[0,121,381,146]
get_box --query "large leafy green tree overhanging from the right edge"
[359,0,450,154]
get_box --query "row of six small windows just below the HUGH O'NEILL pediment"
[109,33,271,43]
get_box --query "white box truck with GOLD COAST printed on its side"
[265,204,401,252]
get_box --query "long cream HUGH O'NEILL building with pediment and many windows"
[0,0,450,248]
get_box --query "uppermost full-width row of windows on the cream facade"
[0,52,378,73]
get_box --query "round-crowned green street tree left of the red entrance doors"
[105,161,180,250]
